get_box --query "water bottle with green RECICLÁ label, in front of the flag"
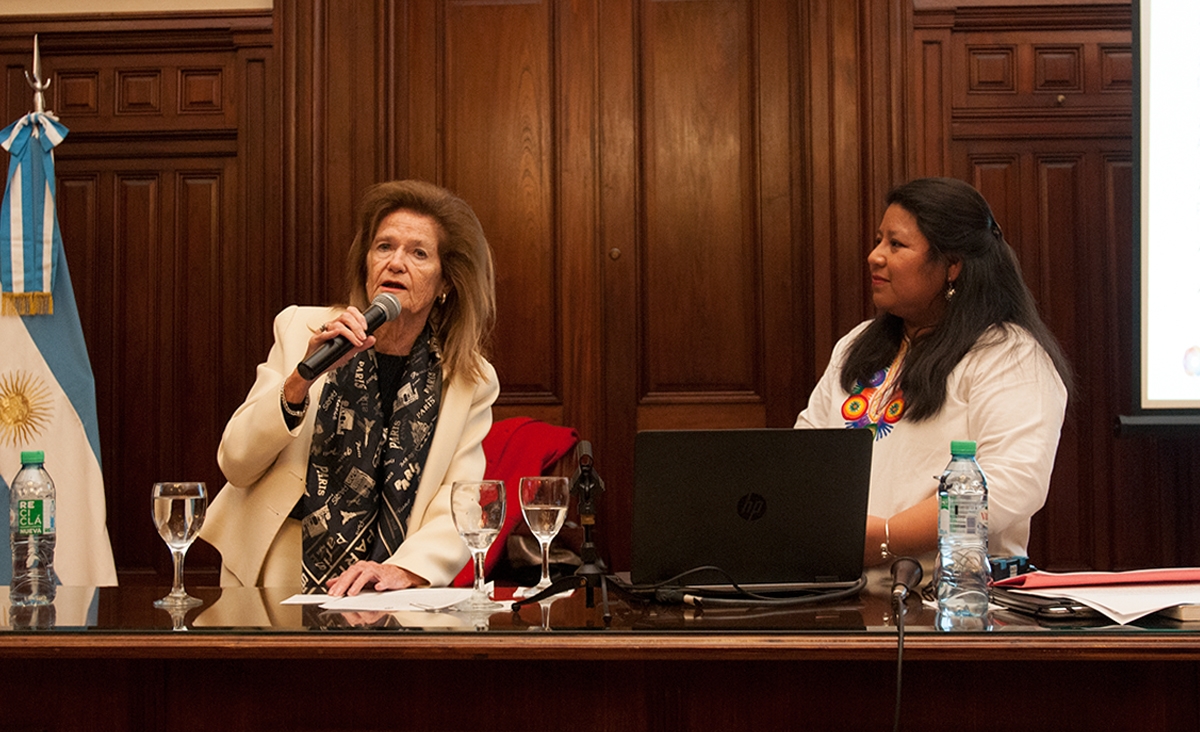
[8,450,58,607]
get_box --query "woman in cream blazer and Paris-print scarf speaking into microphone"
[200,181,499,595]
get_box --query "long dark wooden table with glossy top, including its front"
[0,587,1200,731]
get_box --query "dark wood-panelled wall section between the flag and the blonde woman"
[0,14,274,580]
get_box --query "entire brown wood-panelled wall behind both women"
[7,0,1200,576]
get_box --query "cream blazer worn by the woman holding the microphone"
[200,306,500,586]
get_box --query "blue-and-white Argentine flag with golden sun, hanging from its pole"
[0,113,116,587]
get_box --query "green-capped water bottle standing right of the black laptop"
[937,440,991,630]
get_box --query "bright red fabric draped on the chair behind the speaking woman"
[452,416,580,587]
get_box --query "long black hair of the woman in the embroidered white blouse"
[841,178,1072,421]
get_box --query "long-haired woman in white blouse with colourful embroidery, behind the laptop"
[796,178,1072,576]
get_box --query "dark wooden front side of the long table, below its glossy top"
[0,643,1200,732]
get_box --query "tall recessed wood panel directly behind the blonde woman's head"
[444,2,559,403]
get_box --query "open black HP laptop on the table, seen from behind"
[630,428,872,592]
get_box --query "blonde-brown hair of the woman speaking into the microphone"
[346,180,496,380]
